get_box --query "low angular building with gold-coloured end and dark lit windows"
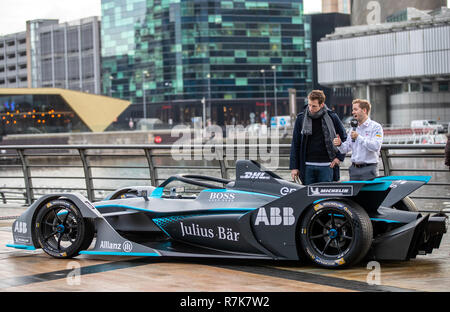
[0,88,130,137]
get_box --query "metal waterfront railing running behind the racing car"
[0,144,450,212]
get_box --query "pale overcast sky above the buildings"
[0,0,322,36]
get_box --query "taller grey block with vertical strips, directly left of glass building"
[27,17,101,94]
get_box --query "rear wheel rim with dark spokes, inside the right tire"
[307,208,354,259]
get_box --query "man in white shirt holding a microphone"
[333,99,383,181]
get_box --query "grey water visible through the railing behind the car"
[0,151,450,209]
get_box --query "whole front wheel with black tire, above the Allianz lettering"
[35,199,95,259]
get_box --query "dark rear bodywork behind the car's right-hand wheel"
[368,215,448,260]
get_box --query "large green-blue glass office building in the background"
[101,0,307,125]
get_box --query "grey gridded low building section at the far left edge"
[0,32,28,88]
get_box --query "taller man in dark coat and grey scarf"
[289,90,347,185]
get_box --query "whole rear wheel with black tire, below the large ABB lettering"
[299,200,373,268]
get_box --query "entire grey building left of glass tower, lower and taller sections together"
[0,17,101,94]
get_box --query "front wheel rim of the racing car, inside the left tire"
[39,207,80,253]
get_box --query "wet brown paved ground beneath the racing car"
[0,206,450,292]
